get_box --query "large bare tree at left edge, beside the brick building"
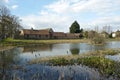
[0,6,21,39]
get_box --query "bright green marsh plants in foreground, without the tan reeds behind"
[48,56,120,77]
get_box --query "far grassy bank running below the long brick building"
[1,38,89,46]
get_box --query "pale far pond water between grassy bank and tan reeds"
[14,41,120,63]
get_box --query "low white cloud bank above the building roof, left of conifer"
[22,13,71,32]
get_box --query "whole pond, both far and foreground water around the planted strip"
[0,41,120,80]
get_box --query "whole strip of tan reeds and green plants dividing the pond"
[29,49,120,77]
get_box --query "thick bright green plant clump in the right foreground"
[77,57,116,75]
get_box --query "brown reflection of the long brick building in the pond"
[23,44,53,52]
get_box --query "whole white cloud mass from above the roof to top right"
[22,0,120,32]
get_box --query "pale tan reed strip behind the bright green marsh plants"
[29,49,120,64]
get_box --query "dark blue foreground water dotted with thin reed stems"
[12,64,100,80]
